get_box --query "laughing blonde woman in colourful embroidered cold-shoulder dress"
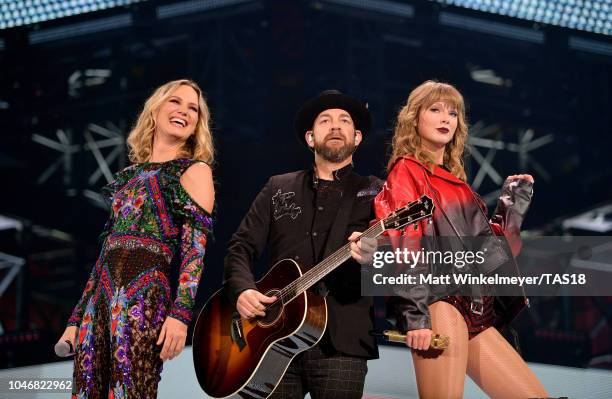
[55,80,215,399]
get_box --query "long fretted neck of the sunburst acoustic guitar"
[281,221,385,302]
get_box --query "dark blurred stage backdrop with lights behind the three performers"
[0,0,612,396]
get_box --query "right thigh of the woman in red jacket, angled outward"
[467,327,548,399]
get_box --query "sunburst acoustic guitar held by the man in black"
[193,195,434,399]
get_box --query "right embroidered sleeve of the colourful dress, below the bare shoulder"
[168,181,213,324]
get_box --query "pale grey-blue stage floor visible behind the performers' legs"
[0,346,612,399]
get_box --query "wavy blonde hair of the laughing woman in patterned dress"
[127,79,215,164]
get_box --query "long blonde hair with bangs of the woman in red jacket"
[387,80,468,181]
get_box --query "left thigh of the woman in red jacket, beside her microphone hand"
[412,301,468,399]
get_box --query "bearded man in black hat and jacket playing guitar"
[225,90,381,399]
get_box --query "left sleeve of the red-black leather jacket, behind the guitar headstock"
[374,159,431,333]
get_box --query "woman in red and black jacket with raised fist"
[374,81,548,398]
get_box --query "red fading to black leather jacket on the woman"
[374,157,533,332]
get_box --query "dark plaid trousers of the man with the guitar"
[270,345,368,399]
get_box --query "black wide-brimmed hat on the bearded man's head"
[293,90,372,145]
